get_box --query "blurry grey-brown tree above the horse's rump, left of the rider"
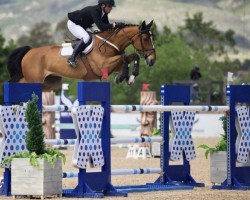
[17,22,54,47]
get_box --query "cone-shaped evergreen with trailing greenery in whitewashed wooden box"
[3,94,66,198]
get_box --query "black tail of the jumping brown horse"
[8,46,31,82]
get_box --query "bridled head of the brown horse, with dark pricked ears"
[132,20,156,66]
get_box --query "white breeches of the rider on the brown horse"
[67,20,90,44]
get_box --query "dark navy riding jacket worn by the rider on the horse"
[68,5,113,31]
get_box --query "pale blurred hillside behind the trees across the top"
[0,0,250,57]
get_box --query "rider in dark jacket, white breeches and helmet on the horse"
[67,0,124,67]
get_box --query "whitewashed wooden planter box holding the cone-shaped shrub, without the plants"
[11,158,62,199]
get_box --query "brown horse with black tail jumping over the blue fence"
[8,21,156,90]
